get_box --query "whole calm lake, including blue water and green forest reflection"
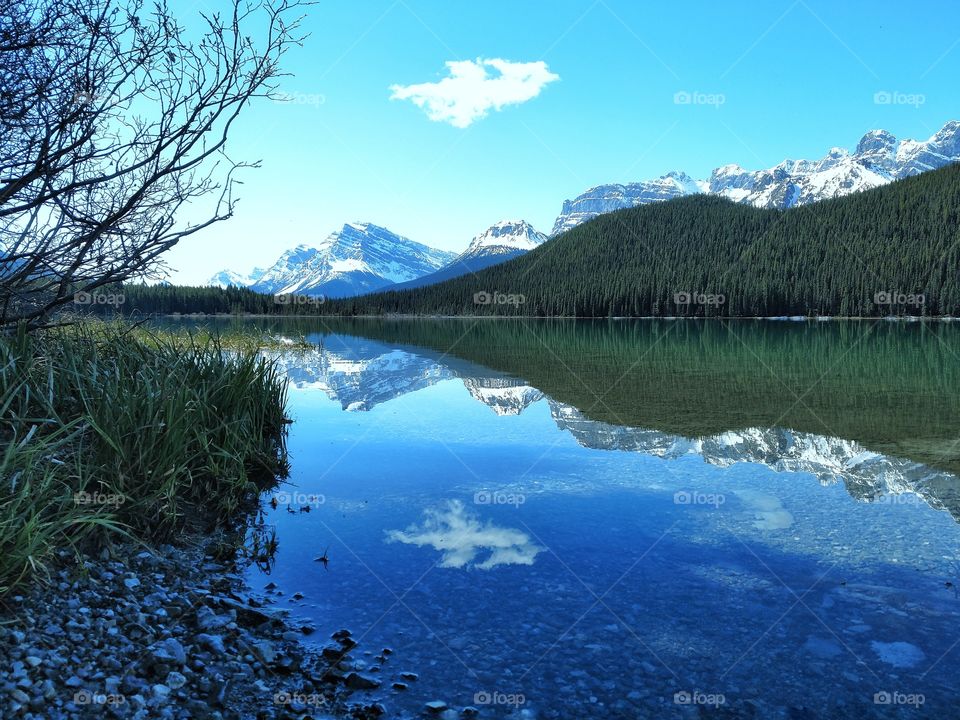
[219,319,960,719]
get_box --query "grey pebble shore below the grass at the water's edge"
[0,538,389,720]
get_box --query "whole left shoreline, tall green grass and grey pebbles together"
[0,322,394,720]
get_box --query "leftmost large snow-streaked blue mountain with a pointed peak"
[214,223,454,297]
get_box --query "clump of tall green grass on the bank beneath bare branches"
[0,320,286,596]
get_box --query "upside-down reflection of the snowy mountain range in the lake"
[266,326,960,524]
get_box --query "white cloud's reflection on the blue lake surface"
[387,500,544,570]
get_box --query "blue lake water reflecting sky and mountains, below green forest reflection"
[250,334,960,718]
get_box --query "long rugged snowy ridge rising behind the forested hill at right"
[553,120,960,235]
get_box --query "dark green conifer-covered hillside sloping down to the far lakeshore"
[320,165,960,317]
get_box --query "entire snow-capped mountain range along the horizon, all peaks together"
[208,120,960,298]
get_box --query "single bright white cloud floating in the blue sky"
[390,58,560,128]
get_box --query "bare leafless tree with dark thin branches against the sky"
[0,0,306,327]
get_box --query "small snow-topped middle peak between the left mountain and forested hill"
[386,220,550,290]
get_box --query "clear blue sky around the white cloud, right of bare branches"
[168,0,960,283]
